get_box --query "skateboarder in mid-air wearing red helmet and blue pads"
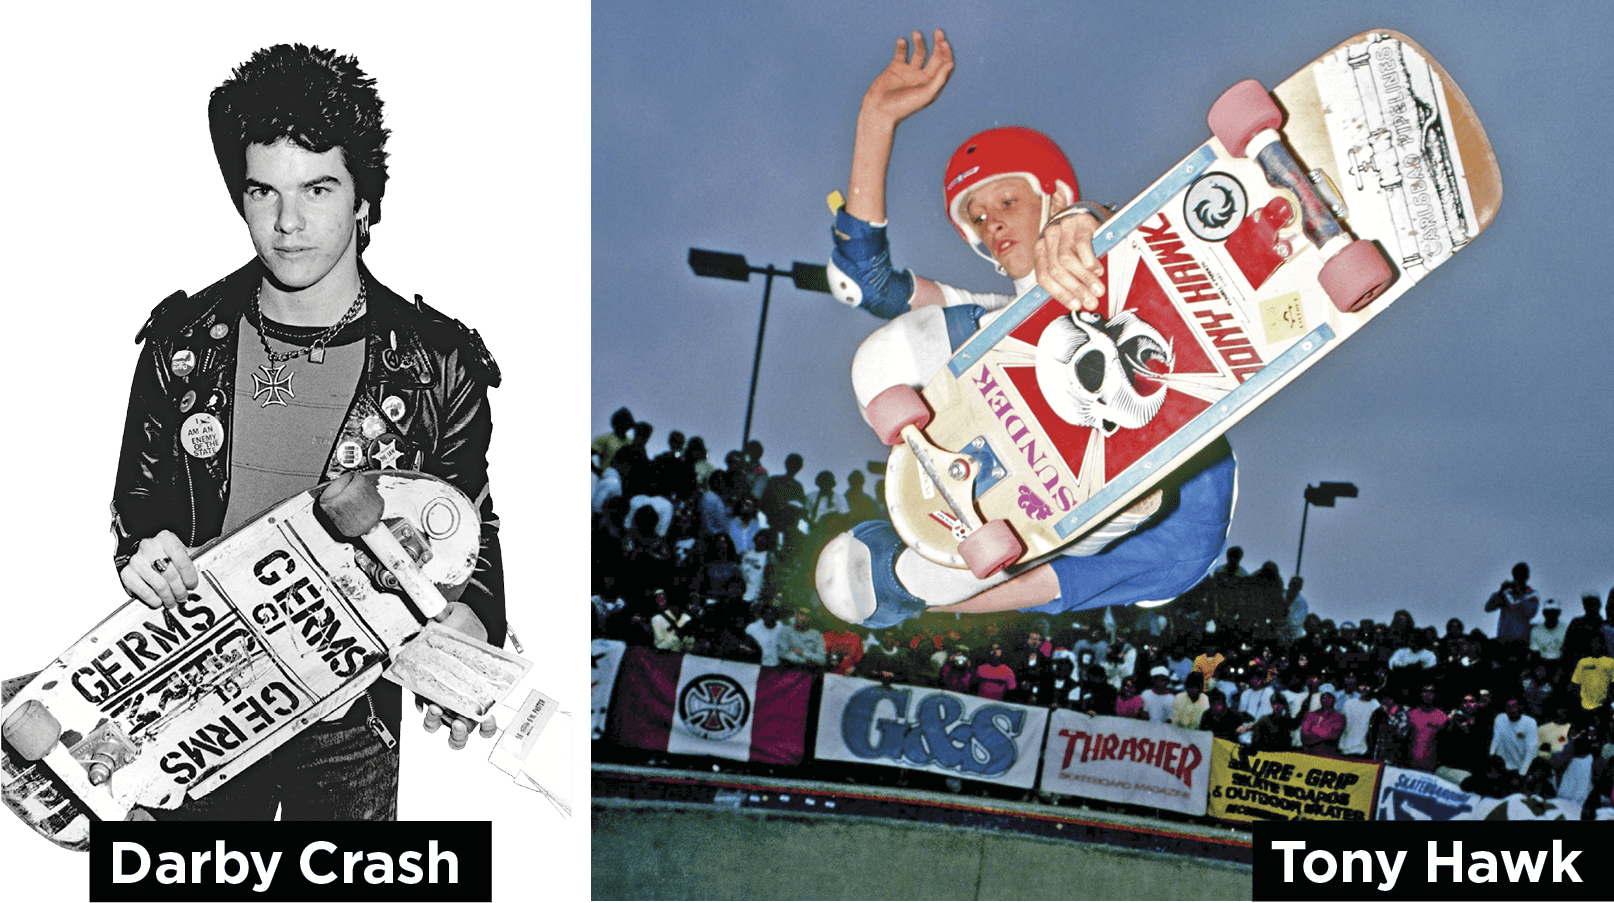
[817,29,1235,628]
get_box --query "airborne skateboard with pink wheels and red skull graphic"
[865,31,1501,577]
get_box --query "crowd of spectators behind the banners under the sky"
[591,409,1614,817]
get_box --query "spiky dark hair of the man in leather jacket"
[208,44,392,245]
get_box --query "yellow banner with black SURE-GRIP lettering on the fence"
[1209,738,1382,822]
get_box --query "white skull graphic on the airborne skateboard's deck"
[1036,310,1175,436]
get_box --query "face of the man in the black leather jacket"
[242,139,370,291]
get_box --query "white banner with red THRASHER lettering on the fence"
[1043,709,1212,816]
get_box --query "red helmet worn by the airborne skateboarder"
[943,126,1081,260]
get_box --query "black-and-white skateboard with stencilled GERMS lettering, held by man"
[0,472,531,851]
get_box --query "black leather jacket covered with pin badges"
[111,260,505,729]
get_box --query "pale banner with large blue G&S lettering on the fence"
[815,674,1047,788]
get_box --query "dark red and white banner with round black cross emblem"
[615,646,813,764]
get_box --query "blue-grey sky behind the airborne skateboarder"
[589,2,1614,632]
